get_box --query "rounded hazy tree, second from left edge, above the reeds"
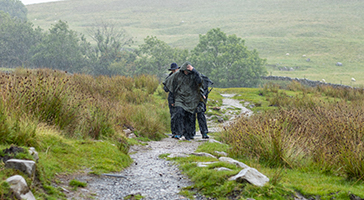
[32,21,87,72]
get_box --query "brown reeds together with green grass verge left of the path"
[0,68,169,199]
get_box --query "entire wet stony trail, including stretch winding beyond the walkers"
[62,94,252,200]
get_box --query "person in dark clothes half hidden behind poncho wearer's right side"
[193,74,214,139]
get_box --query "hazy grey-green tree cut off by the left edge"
[0,12,43,67]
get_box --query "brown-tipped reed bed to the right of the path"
[223,81,364,179]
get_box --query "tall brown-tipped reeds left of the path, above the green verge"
[0,69,168,146]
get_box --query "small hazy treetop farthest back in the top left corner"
[0,0,28,21]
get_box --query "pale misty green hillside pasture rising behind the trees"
[27,0,364,86]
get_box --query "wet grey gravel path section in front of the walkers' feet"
[89,136,201,200]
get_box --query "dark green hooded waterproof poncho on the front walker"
[163,62,203,113]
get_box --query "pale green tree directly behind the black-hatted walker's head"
[135,36,189,79]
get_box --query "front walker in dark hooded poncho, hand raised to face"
[163,61,202,140]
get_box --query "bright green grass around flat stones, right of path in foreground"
[170,143,364,200]
